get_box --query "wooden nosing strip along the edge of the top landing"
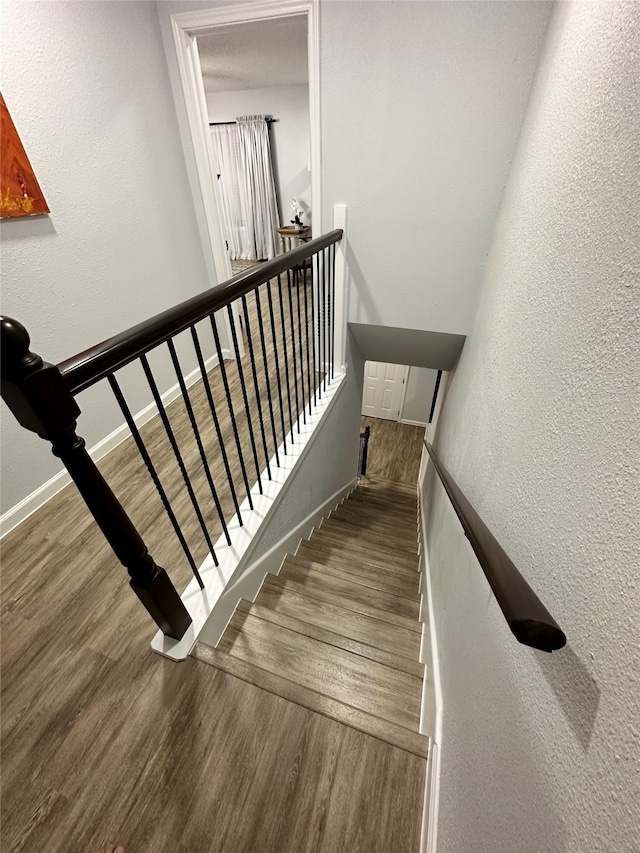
[192,643,429,758]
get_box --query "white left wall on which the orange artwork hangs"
[1,0,218,511]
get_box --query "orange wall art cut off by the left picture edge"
[0,95,49,219]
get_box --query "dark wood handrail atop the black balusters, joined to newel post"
[58,228,342,394]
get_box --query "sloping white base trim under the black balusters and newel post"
[151,374,346,660]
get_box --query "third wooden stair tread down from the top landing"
[277,557,420,620]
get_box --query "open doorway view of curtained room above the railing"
[197,15,311,267]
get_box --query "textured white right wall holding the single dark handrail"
[422,2,640,853]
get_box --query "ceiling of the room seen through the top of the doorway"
[198,15,309,92]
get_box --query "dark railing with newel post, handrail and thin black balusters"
[0,229,343,640]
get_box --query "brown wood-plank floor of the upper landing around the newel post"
[0,278,425,853]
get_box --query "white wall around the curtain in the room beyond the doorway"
[207,85,311,225]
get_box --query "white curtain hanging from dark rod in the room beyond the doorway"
[211,116,278,261]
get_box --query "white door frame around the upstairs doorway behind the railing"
[170,0,322,355]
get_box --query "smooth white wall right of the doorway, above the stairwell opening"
[320,0,551,334]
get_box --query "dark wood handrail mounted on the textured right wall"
[424,441,567,652]
